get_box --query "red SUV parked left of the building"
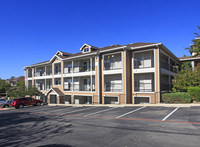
[11,97,43,109]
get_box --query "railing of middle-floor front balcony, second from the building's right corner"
[104,83,122,92]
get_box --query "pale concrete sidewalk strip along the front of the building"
[48,103,200,107]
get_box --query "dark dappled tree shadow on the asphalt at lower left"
[0,112,73,147]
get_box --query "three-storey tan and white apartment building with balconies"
[25,43,180,104]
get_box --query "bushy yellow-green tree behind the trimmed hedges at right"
[172,67,200,92]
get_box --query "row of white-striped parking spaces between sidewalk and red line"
[3,105,200,122]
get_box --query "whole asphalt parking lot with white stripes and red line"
[0,106,200,147]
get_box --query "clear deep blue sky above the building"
[0,0,200,79]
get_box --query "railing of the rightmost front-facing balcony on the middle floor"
[134,82,154,92]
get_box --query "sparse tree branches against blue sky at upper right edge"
[186,26,200,56]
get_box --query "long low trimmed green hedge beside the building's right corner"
[162,92,191,104]
